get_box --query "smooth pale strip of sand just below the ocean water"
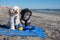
[33,12,60,21]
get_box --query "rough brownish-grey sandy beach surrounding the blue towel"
[0,8,60,40]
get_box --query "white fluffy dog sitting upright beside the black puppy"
[8,6,21,30]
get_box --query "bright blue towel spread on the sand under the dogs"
[0,27,46,38]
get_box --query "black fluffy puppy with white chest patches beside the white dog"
[20,8,32,26]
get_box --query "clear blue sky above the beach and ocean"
[0,0,60,9]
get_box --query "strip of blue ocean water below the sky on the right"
[31,9,60,14]
